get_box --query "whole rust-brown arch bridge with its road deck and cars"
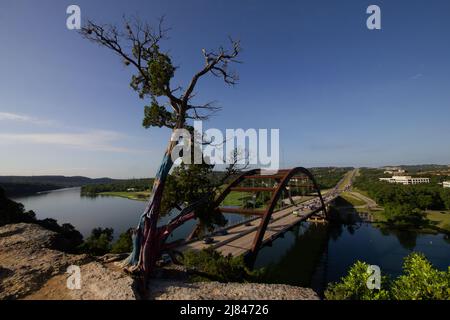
[170,167,344,265]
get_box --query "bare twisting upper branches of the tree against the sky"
[80,17,241,127]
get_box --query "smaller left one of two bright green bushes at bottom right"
[325,261,388,300]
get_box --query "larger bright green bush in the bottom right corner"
[391,253,450,300]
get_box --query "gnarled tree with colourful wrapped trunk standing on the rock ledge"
[80,18,241,276]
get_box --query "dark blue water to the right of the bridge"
[255,223,450,292]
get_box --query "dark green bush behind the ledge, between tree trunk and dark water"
[183,248,258,282]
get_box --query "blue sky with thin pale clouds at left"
[0,0,450,178]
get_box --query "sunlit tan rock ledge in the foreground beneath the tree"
[0,223,319,300]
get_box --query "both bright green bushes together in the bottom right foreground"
[325,252,450,300]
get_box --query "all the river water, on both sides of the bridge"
[14,188,450,290]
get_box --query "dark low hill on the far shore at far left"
[0,176,120,197]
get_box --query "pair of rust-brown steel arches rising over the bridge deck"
[215,167,328,266]
